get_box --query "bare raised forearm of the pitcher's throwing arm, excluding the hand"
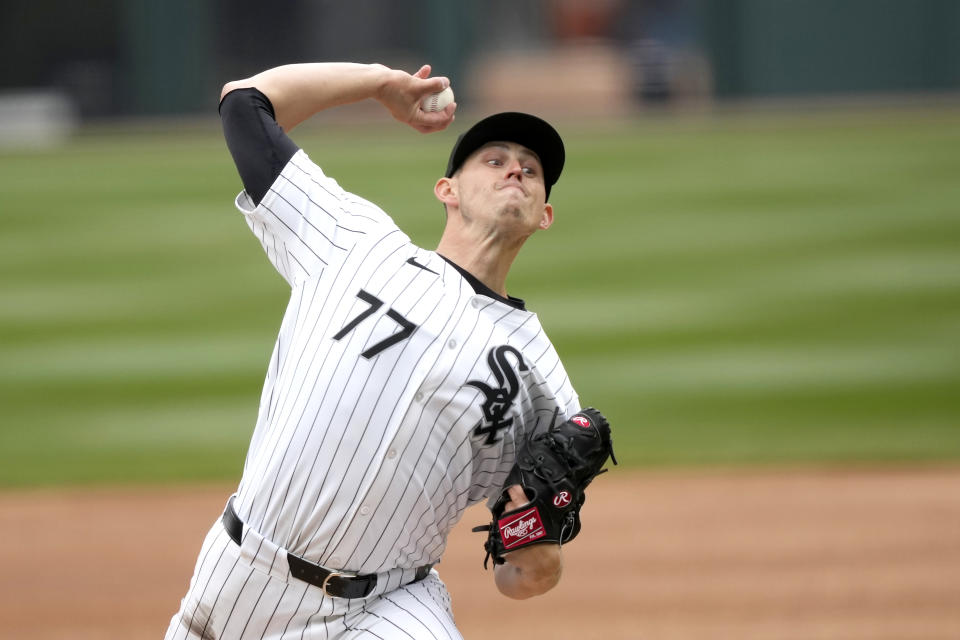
[221,62,395,131]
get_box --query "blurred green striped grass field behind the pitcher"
[0,108,960,486]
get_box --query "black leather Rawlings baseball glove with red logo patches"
[473,407,617,568]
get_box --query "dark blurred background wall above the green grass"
[0,0,960,119]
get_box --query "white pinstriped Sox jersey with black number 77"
[235,151,580,573]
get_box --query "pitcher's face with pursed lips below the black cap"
[457,142,553,235]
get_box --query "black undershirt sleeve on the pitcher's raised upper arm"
[220,88,300,204]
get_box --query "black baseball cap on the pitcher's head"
[444,111,565,199]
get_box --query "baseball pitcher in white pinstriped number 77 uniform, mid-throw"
[166,63,612,640]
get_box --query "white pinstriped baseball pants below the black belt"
[165,518,463,640]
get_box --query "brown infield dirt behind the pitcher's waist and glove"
[0,468,960,640]
